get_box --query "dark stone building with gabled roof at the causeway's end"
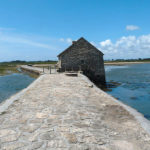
[58,38,105,84]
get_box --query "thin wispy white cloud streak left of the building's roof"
[0,27,55,49]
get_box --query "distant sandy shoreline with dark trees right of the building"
[104,61,150,65]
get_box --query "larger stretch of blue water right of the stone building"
[105,63,150,120]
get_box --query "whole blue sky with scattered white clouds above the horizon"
[0,0,150,62]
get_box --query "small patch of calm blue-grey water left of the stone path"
[0,73,35,102]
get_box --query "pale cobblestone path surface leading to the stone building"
[0,74,150,150]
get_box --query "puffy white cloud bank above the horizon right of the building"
[99,34,150,59]
